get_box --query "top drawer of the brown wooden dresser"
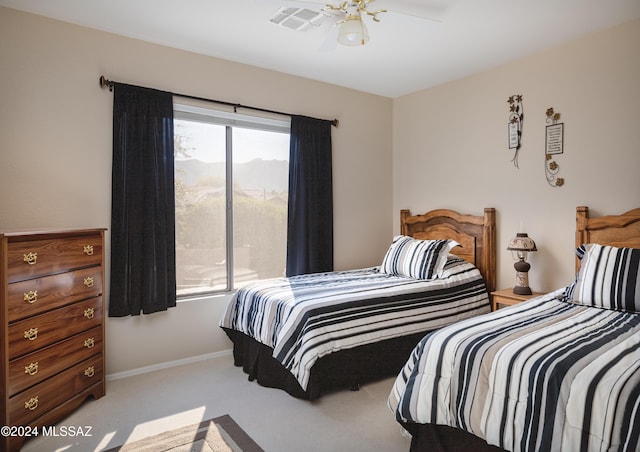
[7,235,102,283]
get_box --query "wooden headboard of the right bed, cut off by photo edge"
[576,206,640,271]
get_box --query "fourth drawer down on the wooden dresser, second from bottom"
[9,326,103,396]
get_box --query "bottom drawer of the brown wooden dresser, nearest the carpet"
[8,355,103,425]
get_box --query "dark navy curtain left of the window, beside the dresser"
[109,83,176,317]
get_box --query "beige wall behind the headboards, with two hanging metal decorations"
[391,21,640,291]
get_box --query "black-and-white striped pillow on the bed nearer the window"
[380,235,459,279]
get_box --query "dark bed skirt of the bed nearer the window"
[223,328,427,400]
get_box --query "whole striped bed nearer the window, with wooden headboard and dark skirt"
[219,208,496,400]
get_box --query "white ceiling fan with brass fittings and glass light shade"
[271,0,444,46]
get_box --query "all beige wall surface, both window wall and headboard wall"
[0,8,640,374]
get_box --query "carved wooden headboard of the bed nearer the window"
[400,207,496,292]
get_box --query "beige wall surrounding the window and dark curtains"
[0,8,397,374]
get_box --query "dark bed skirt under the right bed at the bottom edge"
[403,424,505,452]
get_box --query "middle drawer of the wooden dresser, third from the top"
[8,297,103,360]
